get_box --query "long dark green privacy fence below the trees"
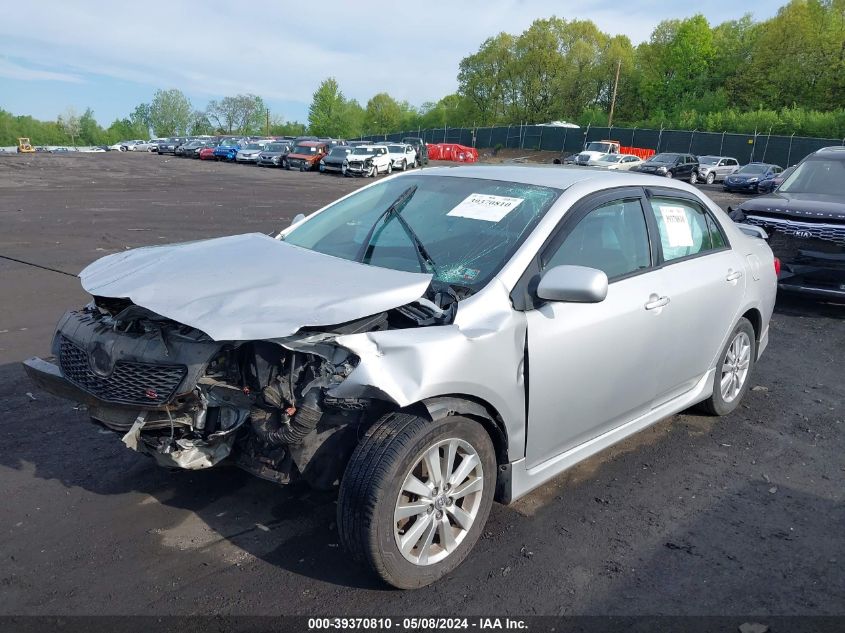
[363,125,845,167]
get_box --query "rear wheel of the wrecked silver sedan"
[701,317,757,415]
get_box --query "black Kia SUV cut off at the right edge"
[728,147,845,300]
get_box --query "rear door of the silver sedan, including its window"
[647,188,746,406]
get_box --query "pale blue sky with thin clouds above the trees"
[0,0,785,125]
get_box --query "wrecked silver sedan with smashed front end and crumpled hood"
[25,166,776,588]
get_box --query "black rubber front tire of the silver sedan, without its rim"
[337,413,496,589]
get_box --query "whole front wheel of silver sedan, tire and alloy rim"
[337,413,496,589]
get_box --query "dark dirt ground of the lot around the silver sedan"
[0,153,845,616]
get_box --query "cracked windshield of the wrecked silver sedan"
[284,176,560,290]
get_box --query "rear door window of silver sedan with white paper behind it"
[651,198,726,262]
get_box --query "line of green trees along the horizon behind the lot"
[0,0,845,145]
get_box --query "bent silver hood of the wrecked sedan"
[79,233,431,341]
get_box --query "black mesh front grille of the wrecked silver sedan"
[59,337,188,406]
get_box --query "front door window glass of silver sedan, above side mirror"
[543,198,651,281]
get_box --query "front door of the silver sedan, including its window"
[526,195,663,468]
